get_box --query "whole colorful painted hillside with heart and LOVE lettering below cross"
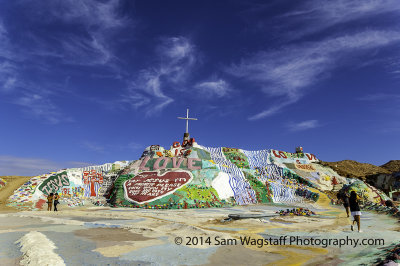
[3,139,390,209]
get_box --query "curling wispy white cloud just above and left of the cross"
[121,37,196,116]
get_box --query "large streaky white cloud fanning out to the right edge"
[226,30,400,120]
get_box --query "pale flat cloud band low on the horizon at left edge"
[0,155,89,176]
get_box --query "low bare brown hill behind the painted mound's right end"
[321,160,391,179]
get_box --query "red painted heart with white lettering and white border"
[124,170,192,204]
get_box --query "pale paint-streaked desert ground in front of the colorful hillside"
[0,184,400,265]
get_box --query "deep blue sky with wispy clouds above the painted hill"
[0,0,400,175]
